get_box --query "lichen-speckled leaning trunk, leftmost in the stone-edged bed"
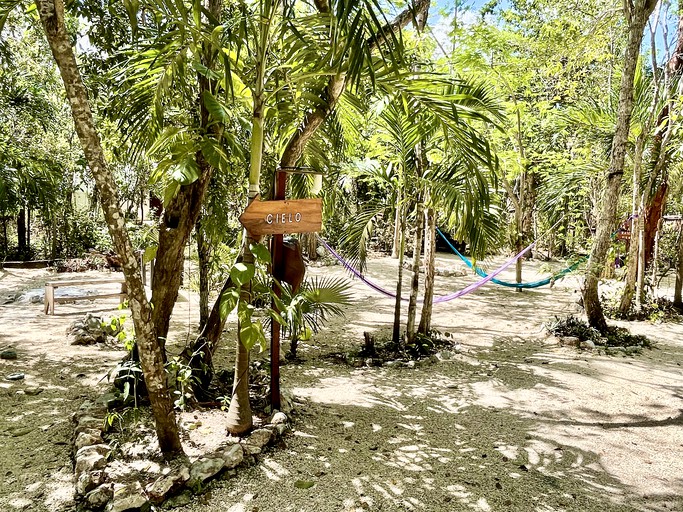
[38,0,183,456]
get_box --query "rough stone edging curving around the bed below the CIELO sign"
[72,404,289,512]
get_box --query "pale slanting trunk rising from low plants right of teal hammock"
[583,0,657,333]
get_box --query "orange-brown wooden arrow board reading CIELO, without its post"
[240,196,323,236]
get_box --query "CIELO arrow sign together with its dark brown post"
[239,190,322,409]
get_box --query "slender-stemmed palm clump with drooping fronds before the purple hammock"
[342,73,500,342]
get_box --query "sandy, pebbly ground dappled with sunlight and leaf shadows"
[0,255,683,512]
